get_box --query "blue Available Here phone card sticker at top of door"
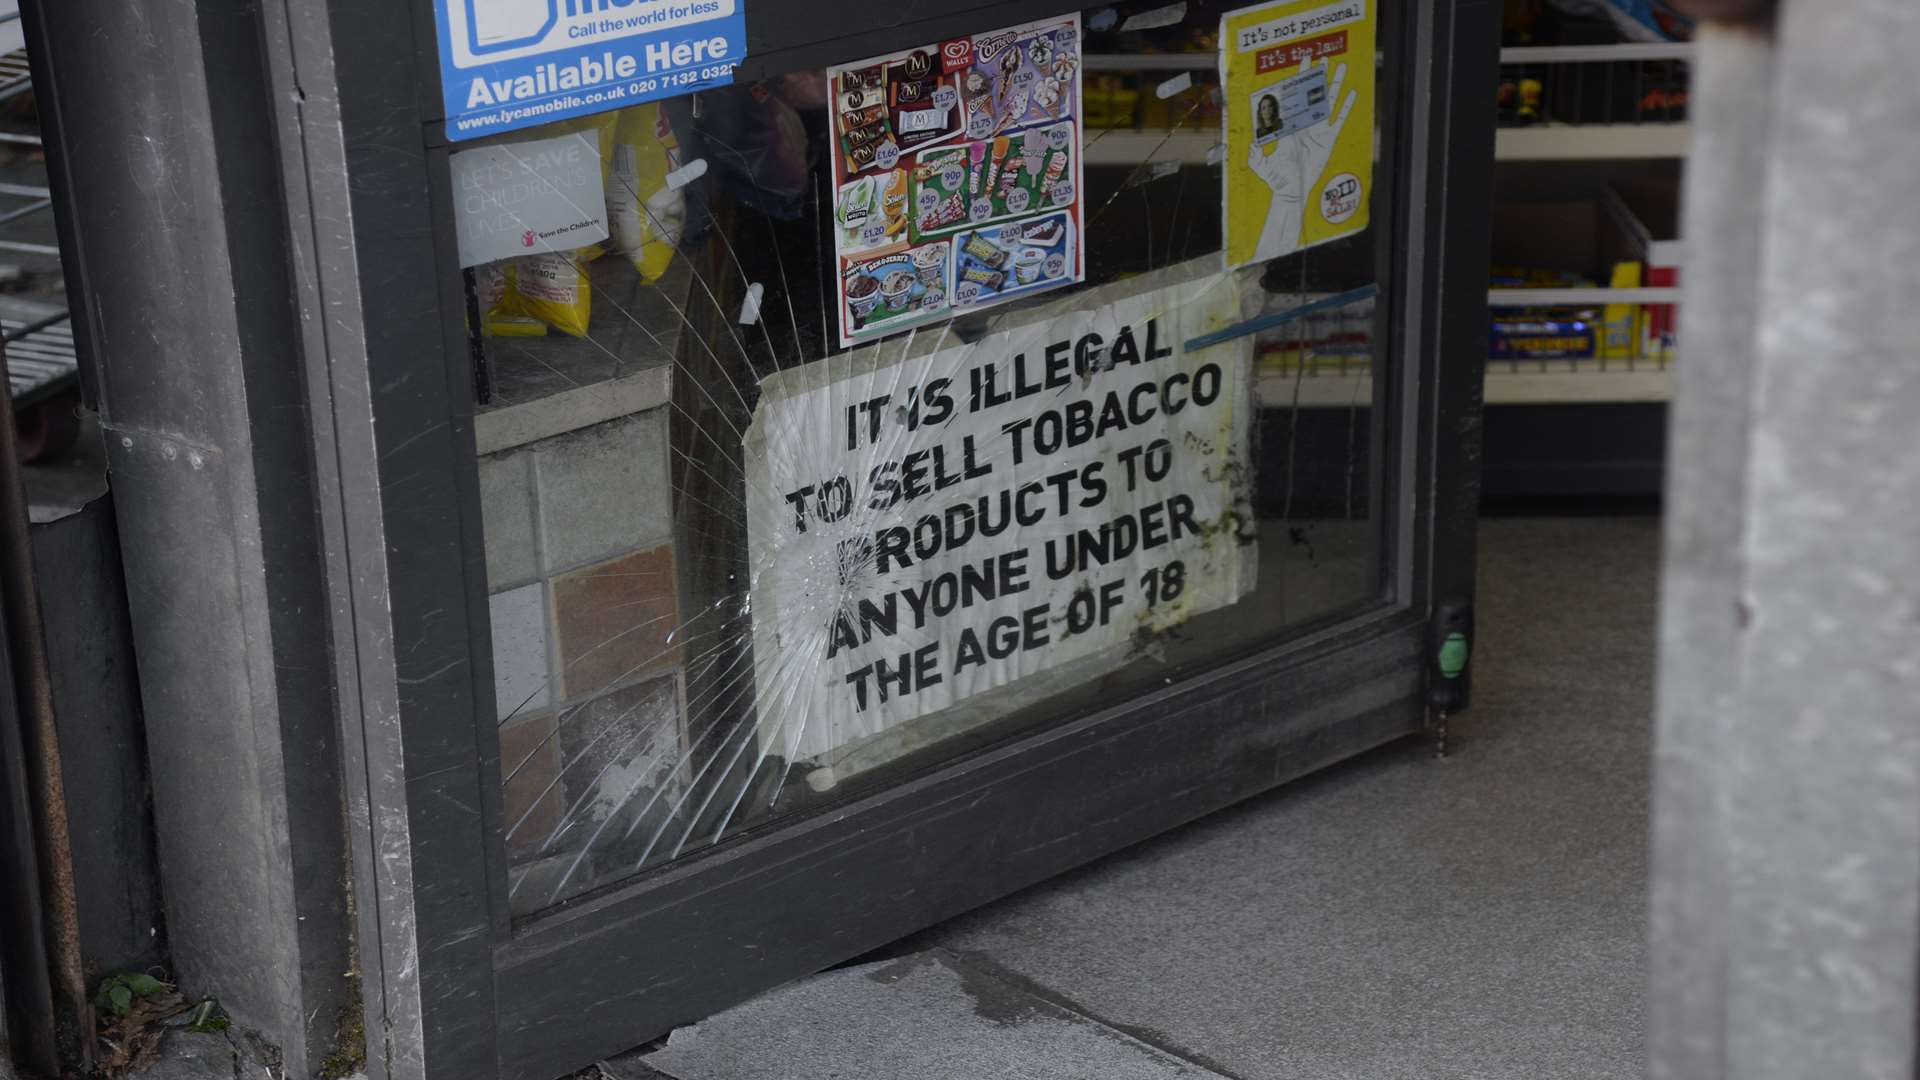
[434,0,747,140]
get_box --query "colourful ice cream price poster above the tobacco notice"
[828,15,1087,346]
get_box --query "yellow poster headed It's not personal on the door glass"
[1219,0,1377,269]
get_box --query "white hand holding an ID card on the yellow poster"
[1246,60,1359,261]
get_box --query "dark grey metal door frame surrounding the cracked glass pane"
[247,0,1496,1080]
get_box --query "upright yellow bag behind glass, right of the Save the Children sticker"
[607,104,687,284]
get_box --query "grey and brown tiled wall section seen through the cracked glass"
[480,407,685,911]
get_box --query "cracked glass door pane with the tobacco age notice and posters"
[464,0,1392,917]
